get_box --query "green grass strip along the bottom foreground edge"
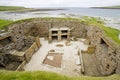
[0,71,120,80]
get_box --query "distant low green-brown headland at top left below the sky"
[0,6,27,11]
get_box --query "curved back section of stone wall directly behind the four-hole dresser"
[9,18,87,39]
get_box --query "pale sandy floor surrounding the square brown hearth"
[24,38,88,76]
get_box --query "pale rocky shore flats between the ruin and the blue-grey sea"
[0,8,120,30]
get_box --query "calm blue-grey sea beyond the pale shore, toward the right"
[41,8,120,18]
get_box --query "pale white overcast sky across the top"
[0,0,120,7]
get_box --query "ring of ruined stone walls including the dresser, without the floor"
[0,18,120,76]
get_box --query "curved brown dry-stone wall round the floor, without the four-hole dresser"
[1,18,120,75]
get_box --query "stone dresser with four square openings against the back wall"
[49,28,70,41]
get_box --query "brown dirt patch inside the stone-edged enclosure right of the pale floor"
[82,53,100,76]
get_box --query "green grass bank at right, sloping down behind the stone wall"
[82,16,120,44]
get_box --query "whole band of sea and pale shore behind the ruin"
[0,7,120,29]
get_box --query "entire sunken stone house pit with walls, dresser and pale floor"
[0,18,120,76]
